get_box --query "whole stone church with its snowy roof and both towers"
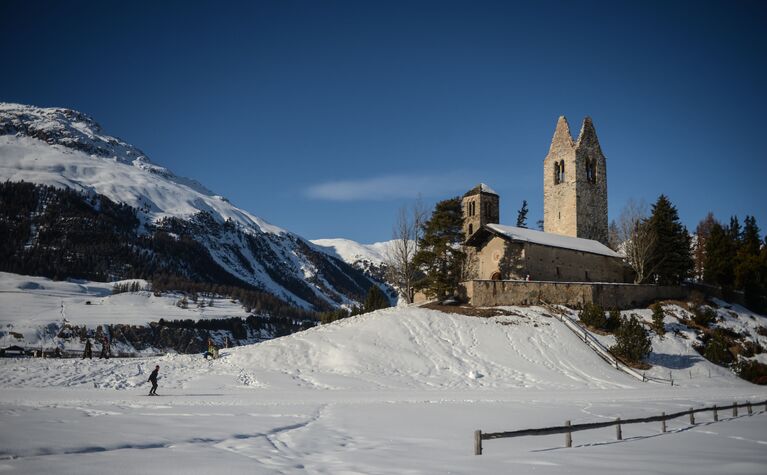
[462,117,632,283]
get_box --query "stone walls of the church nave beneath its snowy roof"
[472,235,631,282]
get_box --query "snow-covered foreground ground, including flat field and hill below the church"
[0,307,767,474]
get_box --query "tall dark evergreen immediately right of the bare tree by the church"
[648,195,693,285]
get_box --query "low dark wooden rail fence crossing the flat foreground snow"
[474,401,767,455]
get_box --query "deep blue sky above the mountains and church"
[0,0,767,242]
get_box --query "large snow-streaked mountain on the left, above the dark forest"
[0,103,372,309]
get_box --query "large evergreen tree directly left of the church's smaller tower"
[414,197,466,299]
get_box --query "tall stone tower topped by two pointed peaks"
[543,116,607,244]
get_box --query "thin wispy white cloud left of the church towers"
[306,173,473,201]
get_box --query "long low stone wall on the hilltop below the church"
[460,280,688,309]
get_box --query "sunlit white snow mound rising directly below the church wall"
[227,308,641,389]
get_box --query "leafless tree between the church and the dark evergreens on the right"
[617,199,658,284]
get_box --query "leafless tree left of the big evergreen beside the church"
[386,197,427,303]
